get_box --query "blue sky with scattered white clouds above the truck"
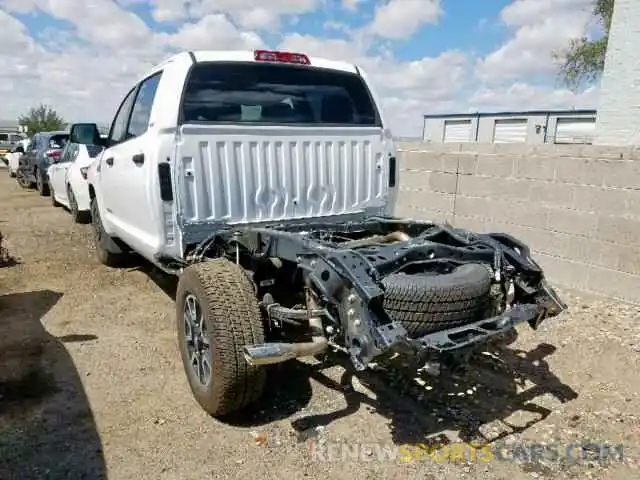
[0,0,597,135]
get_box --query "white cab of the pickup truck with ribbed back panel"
[75,51,398,272]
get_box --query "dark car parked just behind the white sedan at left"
[16,131,69,197]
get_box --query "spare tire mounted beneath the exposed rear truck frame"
[382,263,491,338]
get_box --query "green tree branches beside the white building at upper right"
[556,0,615,89]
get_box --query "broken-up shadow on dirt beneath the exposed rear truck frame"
[293,343,578,446]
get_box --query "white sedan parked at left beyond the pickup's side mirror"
[47,143,103,223]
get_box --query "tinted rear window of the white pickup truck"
[181,62,380,126]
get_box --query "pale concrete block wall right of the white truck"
[396,143,640,304]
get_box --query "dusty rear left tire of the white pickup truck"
[176,259,267,417]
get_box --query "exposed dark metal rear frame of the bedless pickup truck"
[167,212,567,414]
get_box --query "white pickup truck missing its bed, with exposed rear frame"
[71,50,566,416]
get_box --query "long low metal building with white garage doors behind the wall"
[422,110,596,144]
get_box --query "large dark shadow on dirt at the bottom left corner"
[0,290,106,479]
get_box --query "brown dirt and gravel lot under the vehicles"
[0,170,640,480]
